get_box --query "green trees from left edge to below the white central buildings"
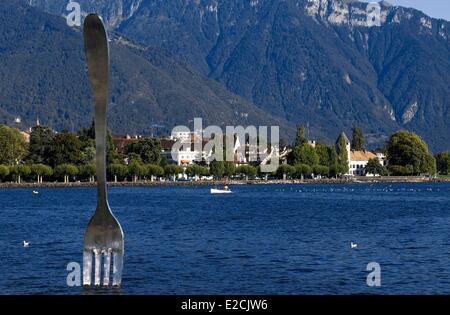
[0,124,264,183]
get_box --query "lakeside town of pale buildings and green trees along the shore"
[0,120,450,186]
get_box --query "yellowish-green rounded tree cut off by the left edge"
[0,125,28,165]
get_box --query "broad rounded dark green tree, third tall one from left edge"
[50,131,82,166]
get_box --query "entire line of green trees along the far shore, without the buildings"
[0,124,450,183]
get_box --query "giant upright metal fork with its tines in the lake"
[83,14,124,287]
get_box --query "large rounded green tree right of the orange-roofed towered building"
[387,130,436,175]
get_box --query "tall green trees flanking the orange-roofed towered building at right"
[278,125,450,178]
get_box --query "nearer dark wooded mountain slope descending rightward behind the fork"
[0,0,293,138]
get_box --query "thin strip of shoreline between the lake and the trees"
[0,176,450,189]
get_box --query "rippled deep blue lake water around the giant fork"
[0,183,450,294]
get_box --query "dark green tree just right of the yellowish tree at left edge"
[27,126,55,165]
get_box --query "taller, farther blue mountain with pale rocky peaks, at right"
[30,0,450,150]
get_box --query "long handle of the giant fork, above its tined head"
[83,14,109,210]
